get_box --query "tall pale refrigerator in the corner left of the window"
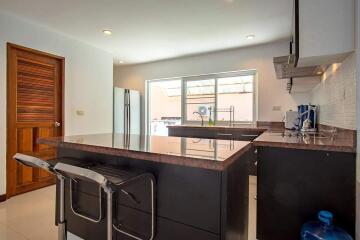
[114,87,140,134]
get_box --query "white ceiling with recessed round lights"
[0,0,292,64]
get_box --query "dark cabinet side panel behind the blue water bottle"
[257,147,356,240]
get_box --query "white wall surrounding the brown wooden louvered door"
[0,12,113,194]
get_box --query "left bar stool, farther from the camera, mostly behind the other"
[13,153,90,240]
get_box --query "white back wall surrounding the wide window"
[114,41,310,133]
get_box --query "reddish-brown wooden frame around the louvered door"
[5,42,65,199]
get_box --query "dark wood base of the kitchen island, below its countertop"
[58,148,253,240]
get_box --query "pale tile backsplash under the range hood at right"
[311,53,356,130]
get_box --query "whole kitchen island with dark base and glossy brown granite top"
[38,134,253,240]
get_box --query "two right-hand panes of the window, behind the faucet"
[183,71,256,124]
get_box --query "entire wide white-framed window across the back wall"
[146,71,256,135]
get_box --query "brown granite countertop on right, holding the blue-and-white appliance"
[253,130,356,153]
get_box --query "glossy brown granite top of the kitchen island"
[38,133,251,171]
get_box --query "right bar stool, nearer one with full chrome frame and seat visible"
[54,162,155,240]
